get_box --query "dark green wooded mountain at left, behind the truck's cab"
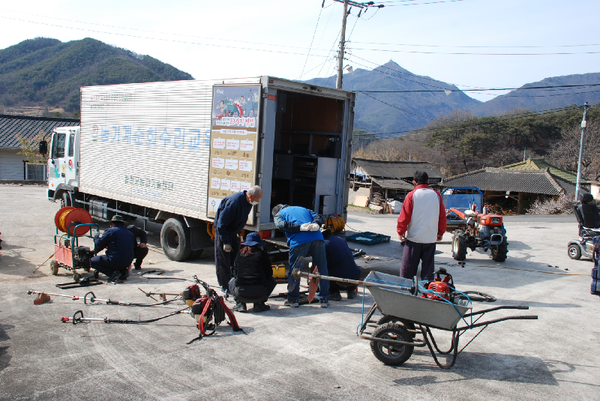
[0,38,192,113]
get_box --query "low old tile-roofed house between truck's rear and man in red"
[350,159,444,208]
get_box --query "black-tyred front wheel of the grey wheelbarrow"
[371,322,414,366]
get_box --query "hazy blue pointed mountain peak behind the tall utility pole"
[308,61,481,138]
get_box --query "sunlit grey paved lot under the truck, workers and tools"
[0,185,600,400]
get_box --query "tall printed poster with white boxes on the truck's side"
[206,85,260,225]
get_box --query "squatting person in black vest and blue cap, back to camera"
[229,233,277,312]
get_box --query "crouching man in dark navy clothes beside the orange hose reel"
[90,214,136,281]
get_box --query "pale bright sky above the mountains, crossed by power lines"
[0,0,600,101]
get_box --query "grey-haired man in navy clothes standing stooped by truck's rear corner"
[215,186,262,294]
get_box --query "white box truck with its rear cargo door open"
[48,76,355,261]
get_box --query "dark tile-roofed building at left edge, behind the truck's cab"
[0,114,79,181]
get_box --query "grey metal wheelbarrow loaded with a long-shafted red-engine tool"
[293,269,538,369]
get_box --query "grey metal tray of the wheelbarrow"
[364,271,472,330]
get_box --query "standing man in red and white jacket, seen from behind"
[397,171,446,280]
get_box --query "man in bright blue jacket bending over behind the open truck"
[271,204,329,308]
